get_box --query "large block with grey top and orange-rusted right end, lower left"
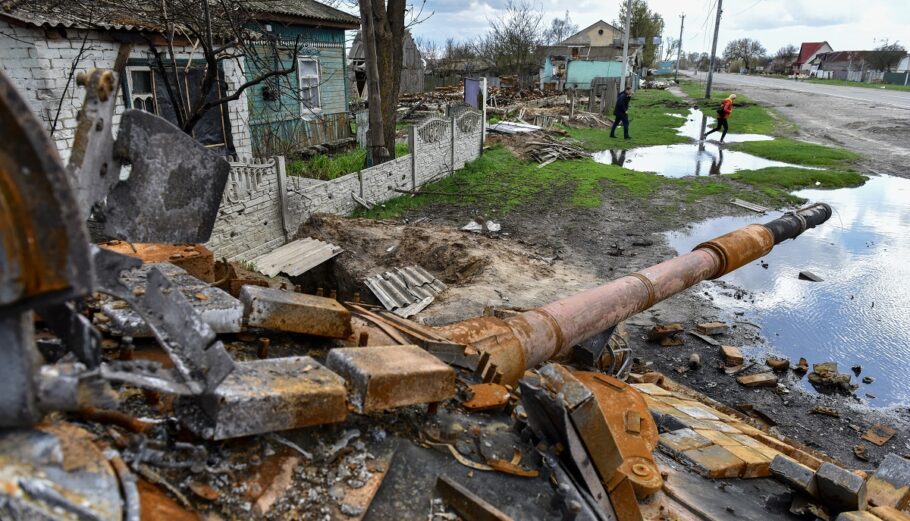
[177,356,347,440]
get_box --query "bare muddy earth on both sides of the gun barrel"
[300,92,910,469]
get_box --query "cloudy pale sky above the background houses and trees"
[413,0,910,54]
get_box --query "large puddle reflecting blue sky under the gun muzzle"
[667,177,910,406]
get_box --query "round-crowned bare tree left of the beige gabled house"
[475,0,544,80]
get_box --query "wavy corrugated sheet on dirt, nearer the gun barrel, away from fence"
[364,266,446,318]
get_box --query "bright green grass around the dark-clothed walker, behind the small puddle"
[567,89,688,151]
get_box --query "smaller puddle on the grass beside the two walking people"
[594,109,811,177]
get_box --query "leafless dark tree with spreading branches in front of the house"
[16,0,299,133]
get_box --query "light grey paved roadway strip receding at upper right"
[693,72,910,110]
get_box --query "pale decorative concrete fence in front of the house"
[207,109,483,261]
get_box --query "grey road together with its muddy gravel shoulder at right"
[692,73,910,177]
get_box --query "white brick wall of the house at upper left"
[0,21,252,163]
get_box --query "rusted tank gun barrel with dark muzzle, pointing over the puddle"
[440,203,831,383]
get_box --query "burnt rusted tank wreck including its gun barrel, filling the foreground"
[0,70,910,521]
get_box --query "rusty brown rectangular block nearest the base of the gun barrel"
[326,345,455,414]
